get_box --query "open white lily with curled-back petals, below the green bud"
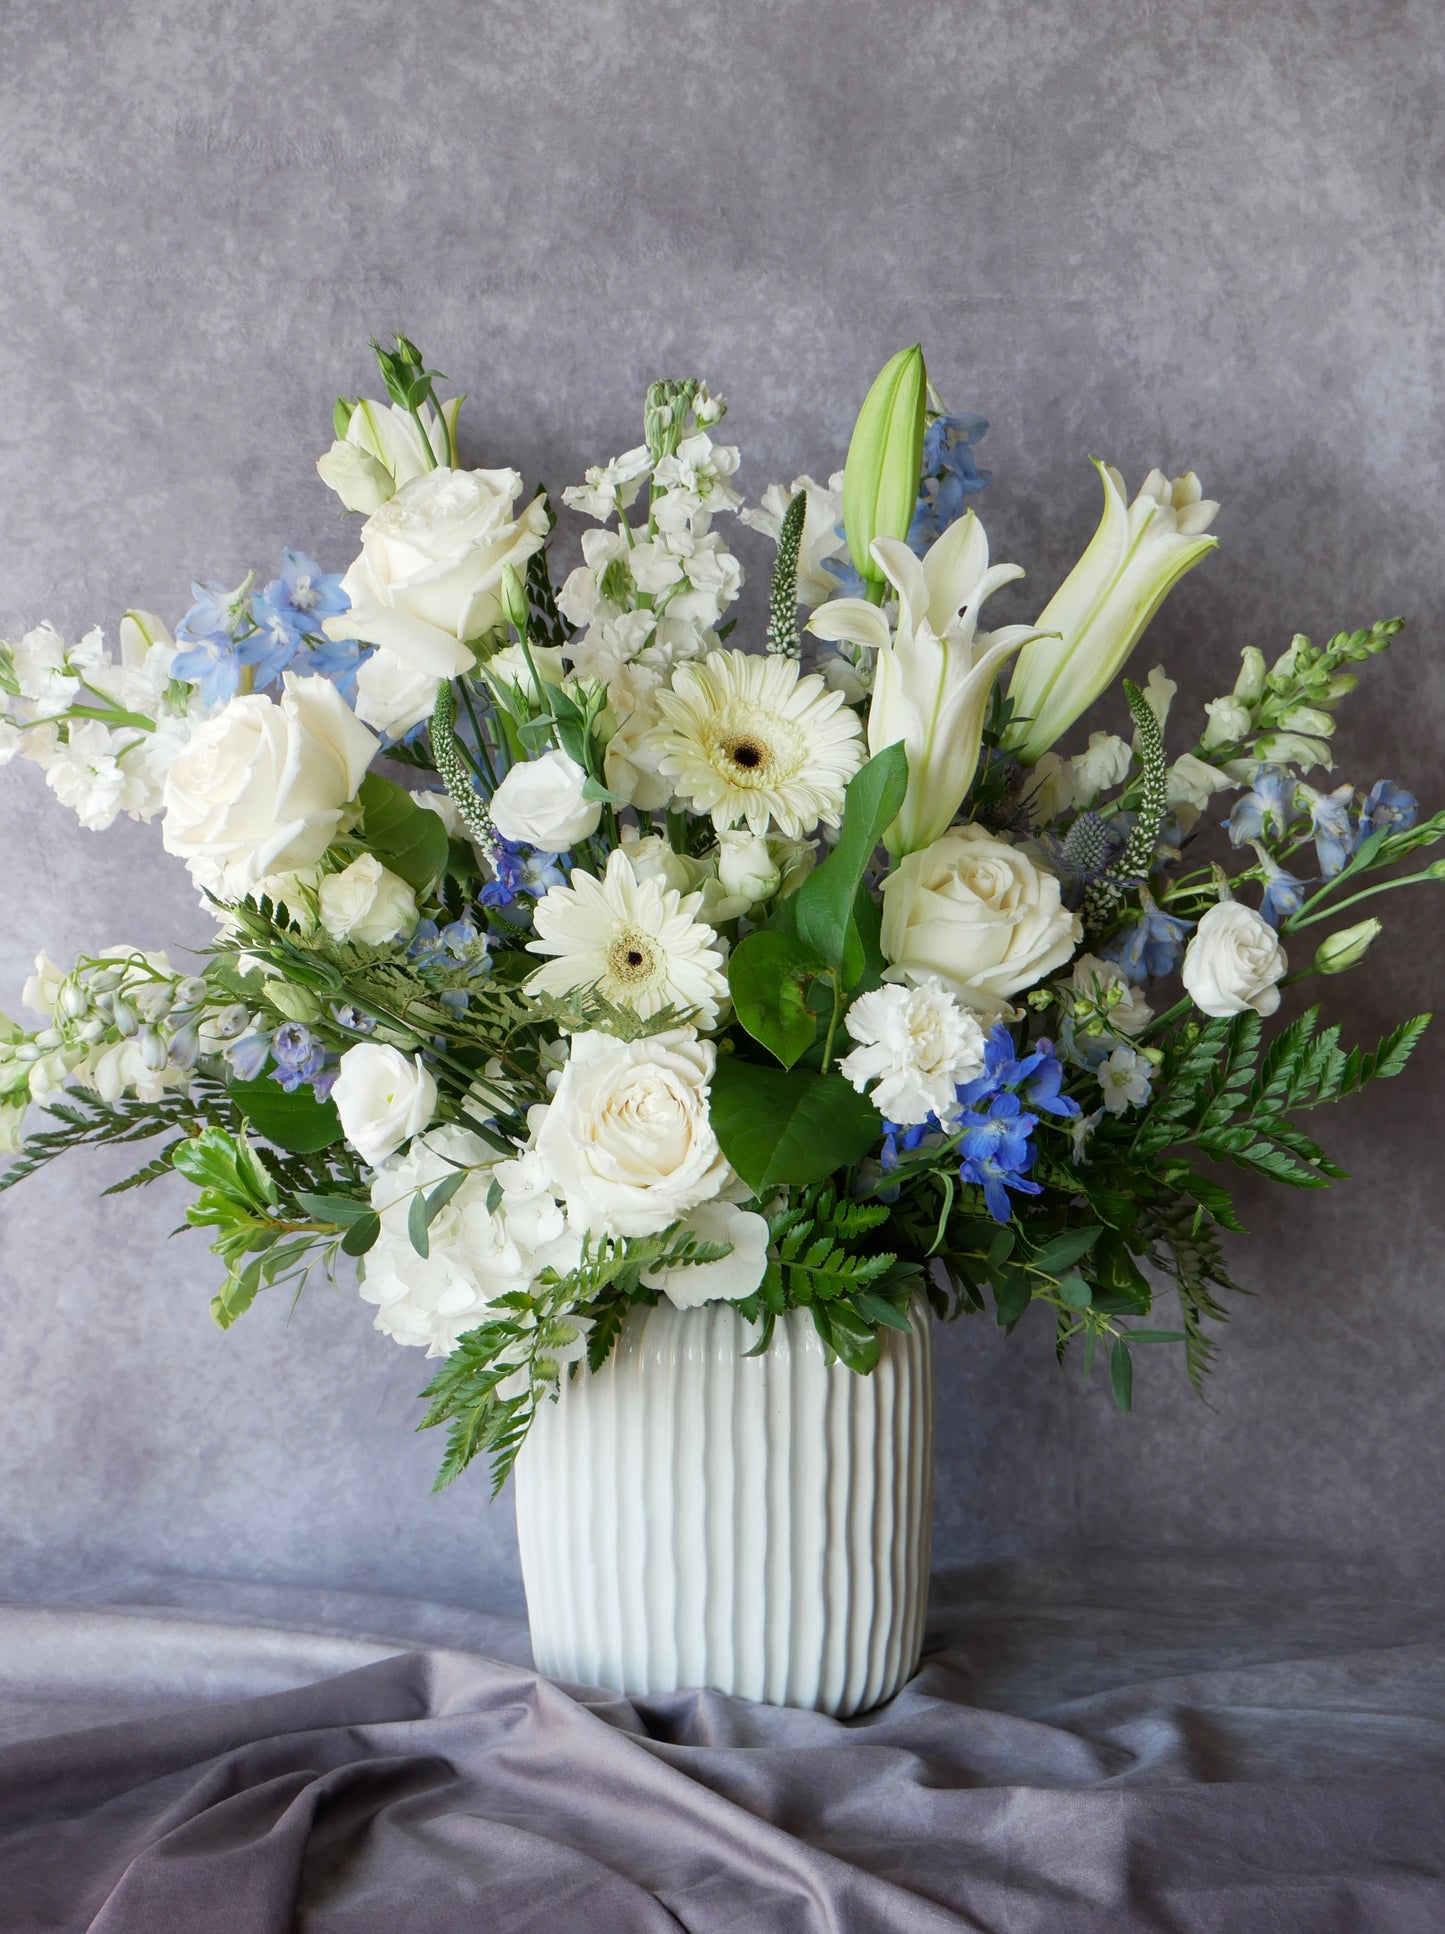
[809,511,1037,859]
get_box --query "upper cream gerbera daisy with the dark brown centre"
[648,650,863,839]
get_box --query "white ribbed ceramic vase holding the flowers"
[516,1300,932,1715]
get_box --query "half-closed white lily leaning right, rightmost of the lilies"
[1004,458,1219,764]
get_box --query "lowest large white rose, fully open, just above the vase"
[533,1027,729,1236]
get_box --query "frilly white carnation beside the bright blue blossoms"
[838,981,985,1128]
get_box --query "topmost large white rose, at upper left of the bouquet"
[323,470,547,679]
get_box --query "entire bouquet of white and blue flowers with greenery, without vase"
[0,337,1445,1483]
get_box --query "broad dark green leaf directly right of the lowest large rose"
[712,1056,882,1195]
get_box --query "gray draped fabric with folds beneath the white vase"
[0,1561,1445,1934]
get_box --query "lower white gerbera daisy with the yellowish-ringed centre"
[528,849,727,1027]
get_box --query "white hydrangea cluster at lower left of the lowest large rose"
[360,1124,582,1356]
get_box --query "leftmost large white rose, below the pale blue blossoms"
[161,671,377,899]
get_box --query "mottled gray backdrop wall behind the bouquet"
[0,0,1445,1605]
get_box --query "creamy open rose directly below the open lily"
[882,826,1083,1019]
